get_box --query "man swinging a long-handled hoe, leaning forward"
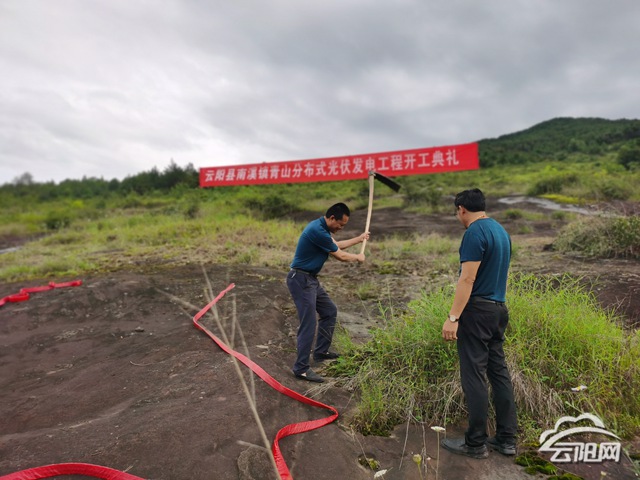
[287,203,369,383]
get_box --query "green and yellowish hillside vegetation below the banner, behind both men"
[0,146,640,281]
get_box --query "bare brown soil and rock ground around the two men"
[0,202,640,480]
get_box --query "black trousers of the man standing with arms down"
[457,302,518,446]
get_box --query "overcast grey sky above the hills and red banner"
[0,0,640,184]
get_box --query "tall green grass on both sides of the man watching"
[332,274,640,441]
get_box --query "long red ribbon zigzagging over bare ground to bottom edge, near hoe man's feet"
[194,283,338,480]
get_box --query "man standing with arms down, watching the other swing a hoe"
[442,188,517,458]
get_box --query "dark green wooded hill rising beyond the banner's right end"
[478,117,640,167]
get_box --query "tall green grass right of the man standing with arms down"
[505,275,640,435]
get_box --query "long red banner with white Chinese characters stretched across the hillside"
[200,143,479,187]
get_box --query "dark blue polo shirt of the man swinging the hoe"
[291,217,338,275]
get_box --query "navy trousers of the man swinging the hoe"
[287,270,338,374]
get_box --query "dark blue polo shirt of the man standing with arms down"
[460,218,511,302]
